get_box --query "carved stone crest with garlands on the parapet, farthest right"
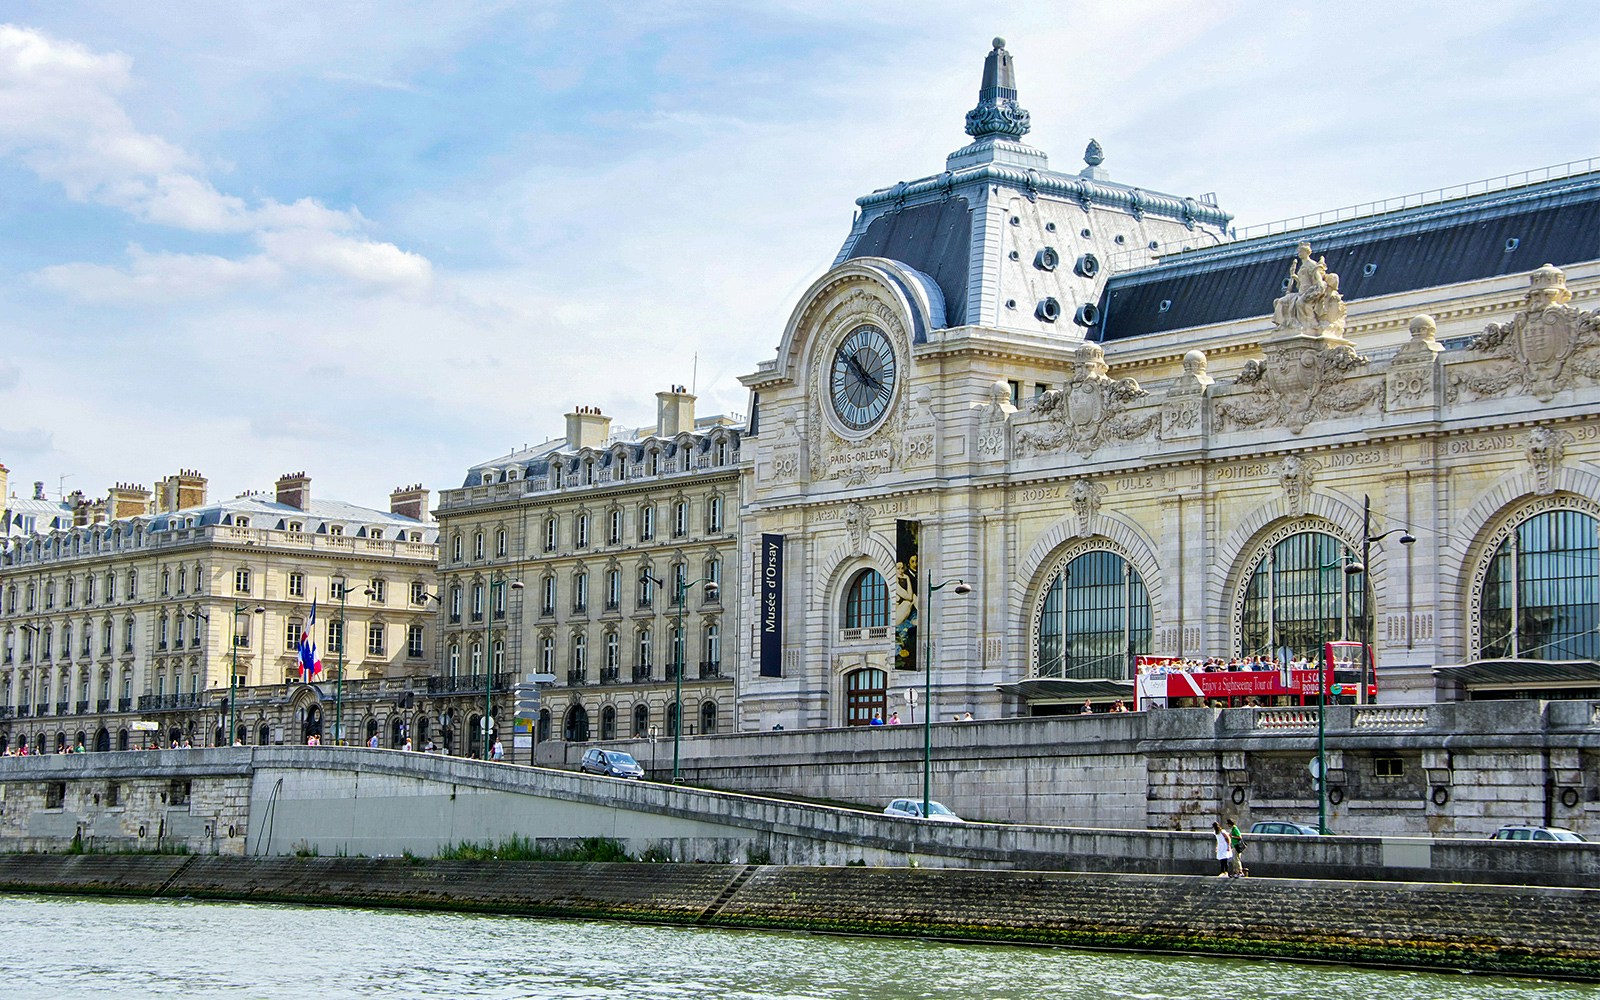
[1450,264,1600,402]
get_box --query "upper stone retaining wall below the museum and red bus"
[566,701,1600,840]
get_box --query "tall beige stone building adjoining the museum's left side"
[437,387,744,739]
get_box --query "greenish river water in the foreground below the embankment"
[0,894,1600,1000]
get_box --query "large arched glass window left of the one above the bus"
[1034,549,1150,678]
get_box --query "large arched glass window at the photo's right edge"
[1478,510,1600,659]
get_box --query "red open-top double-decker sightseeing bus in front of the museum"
[1134,642,1378,709]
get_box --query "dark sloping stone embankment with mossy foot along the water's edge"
[0,854,1600,979]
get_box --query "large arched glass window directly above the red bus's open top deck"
[1238,531,1365,662]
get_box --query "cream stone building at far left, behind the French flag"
[0,470,437,752]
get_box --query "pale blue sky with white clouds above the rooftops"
[0,0,1600,509]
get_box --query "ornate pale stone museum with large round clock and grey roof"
[738,38,1600,730]
